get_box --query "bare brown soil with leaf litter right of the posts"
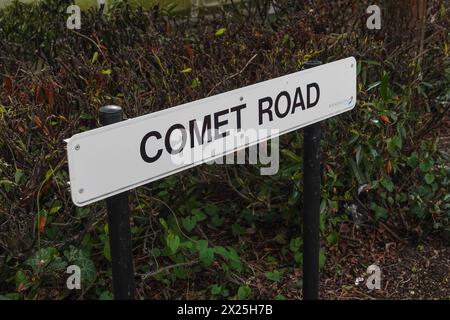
[321,222,450,299]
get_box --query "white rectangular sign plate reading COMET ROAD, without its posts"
[67,57,356,206]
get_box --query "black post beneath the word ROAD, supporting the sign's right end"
[303,61,322,300]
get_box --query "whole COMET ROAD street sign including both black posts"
[67,57,356,299]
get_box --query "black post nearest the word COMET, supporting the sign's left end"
[100,105,135,300]
